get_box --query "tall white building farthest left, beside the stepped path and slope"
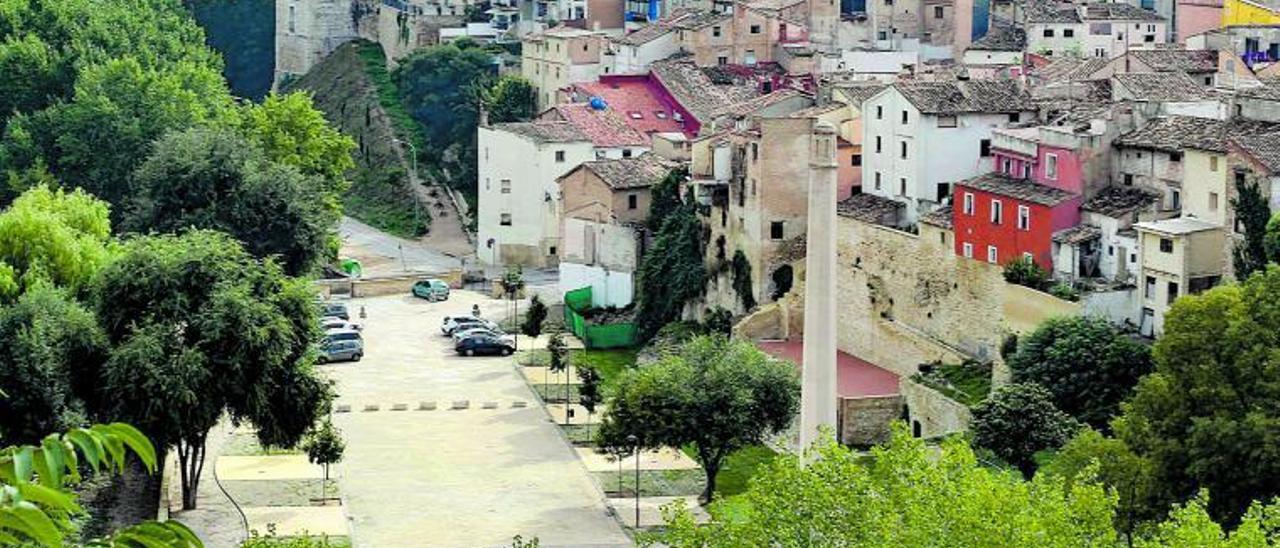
[476,122,595,268]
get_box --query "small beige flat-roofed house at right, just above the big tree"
[1133,216,1226,337]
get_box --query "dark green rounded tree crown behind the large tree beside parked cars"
[128,128,338,274]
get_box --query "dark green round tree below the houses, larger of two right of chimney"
[1009,316,1151,428]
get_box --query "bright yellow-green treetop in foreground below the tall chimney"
[658,424,1116,548]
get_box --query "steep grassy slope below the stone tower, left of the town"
[282,41,430,237]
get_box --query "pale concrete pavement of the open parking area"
[323,291,631,547]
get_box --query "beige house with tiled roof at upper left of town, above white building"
[520,27,608,110]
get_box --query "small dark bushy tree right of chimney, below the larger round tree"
[972,383,1079,478]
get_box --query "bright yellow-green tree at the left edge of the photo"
[0,186,111,299]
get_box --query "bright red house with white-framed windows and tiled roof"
[952,173,1080,271]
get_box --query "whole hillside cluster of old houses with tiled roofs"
[476,0,1280,438]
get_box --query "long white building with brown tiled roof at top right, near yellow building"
[1027,3,1169,59]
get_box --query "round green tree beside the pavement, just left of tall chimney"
[596,335,800,503]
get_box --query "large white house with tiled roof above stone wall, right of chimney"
[861,79,1036,223]
